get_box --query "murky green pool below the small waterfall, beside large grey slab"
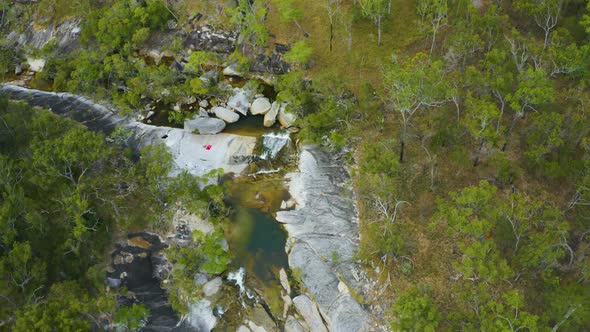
[226,174,289,317]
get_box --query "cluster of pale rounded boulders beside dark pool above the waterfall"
[184,88,297,135]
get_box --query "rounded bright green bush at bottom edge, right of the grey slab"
[391,287,441,332]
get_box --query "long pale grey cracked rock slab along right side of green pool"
[276,146,370,331]
